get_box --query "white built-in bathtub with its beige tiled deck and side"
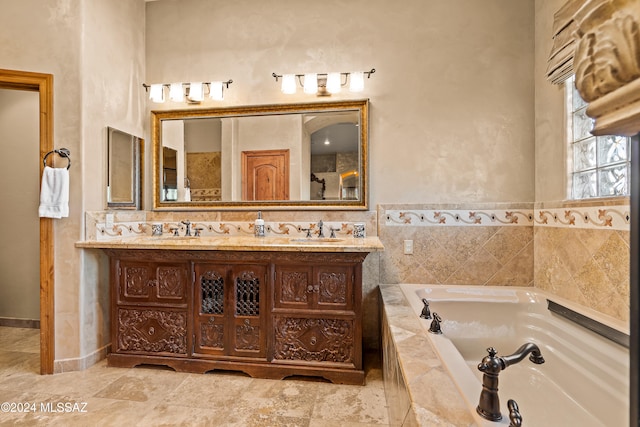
[381,285,629,427]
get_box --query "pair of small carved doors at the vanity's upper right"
[274,264,355,311]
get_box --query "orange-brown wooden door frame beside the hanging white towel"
[0,69,55,374]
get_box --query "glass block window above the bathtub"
[565,77,630,199]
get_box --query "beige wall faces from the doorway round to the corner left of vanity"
[0,0,147,369]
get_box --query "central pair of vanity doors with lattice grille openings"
[194,263,268,358]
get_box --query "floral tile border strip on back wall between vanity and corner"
[384,209,533,227]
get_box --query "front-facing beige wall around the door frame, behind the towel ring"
[0,0,82,358]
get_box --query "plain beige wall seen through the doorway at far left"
[0,89,40,320]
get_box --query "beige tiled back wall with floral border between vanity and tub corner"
[378,203,534,286]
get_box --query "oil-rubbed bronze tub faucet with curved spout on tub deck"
[476,342,544,421]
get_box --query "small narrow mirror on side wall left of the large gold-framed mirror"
[107,127,144,209]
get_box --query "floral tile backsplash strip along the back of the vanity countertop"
[95,221,360,241]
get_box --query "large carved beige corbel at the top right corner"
[573,0,640,135]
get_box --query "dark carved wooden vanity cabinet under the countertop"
[104,248,368,384]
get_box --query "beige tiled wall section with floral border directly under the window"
[534,200,630,322]
